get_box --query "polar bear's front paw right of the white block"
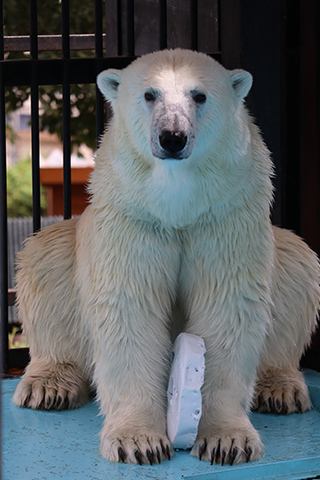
[191,432,263,465]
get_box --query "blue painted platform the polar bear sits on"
[2,371,320,480]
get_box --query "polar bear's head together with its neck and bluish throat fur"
[96,49,262,227]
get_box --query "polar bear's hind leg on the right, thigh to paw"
[253,227,320,414]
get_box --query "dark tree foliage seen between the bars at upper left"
[3,0,104,149]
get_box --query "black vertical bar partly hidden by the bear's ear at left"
[95,0,104,145]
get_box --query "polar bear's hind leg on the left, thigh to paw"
[13,219,92,410]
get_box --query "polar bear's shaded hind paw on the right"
[253,370,312,415]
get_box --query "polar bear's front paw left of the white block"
[100,433,173,465]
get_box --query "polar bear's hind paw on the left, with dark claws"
[12,361,90,410]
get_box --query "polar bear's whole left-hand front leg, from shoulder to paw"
[88,220,179,464]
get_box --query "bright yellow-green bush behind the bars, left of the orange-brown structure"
[7,158,46,217]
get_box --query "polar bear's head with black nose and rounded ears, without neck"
[97,49,252,163]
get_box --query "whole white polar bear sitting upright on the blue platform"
[13,49,320,464]
